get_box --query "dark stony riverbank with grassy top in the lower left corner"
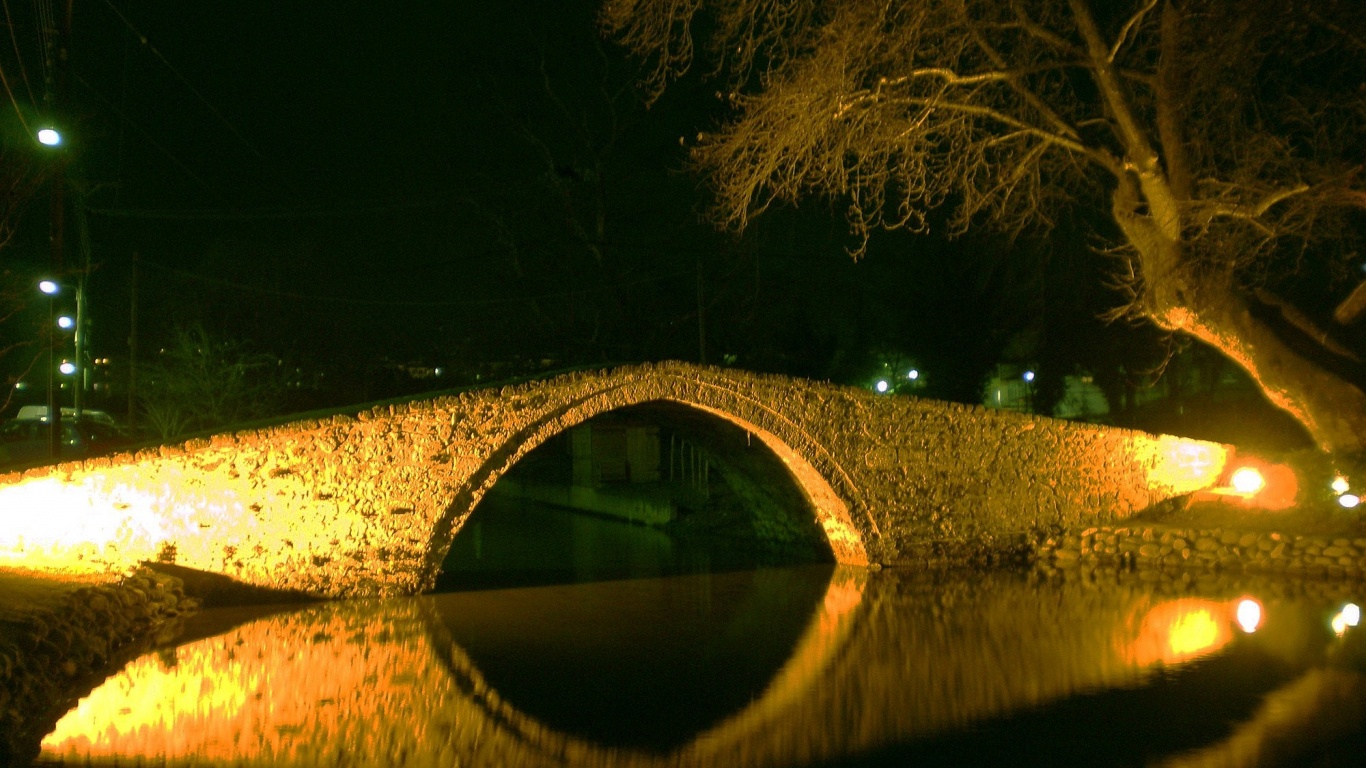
[0,568,198,765]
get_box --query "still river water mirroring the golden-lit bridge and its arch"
[42,567,1366,767]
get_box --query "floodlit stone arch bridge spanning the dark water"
[0,364,1228,597]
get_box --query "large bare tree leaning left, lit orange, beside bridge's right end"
[601,0,1366,458]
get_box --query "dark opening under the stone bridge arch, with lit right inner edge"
[436,399,861,590]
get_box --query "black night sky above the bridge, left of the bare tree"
[0,0,1234,418]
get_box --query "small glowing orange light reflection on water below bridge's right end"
[1128,597,1233,666]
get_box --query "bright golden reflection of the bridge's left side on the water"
[42,607,454,765]
